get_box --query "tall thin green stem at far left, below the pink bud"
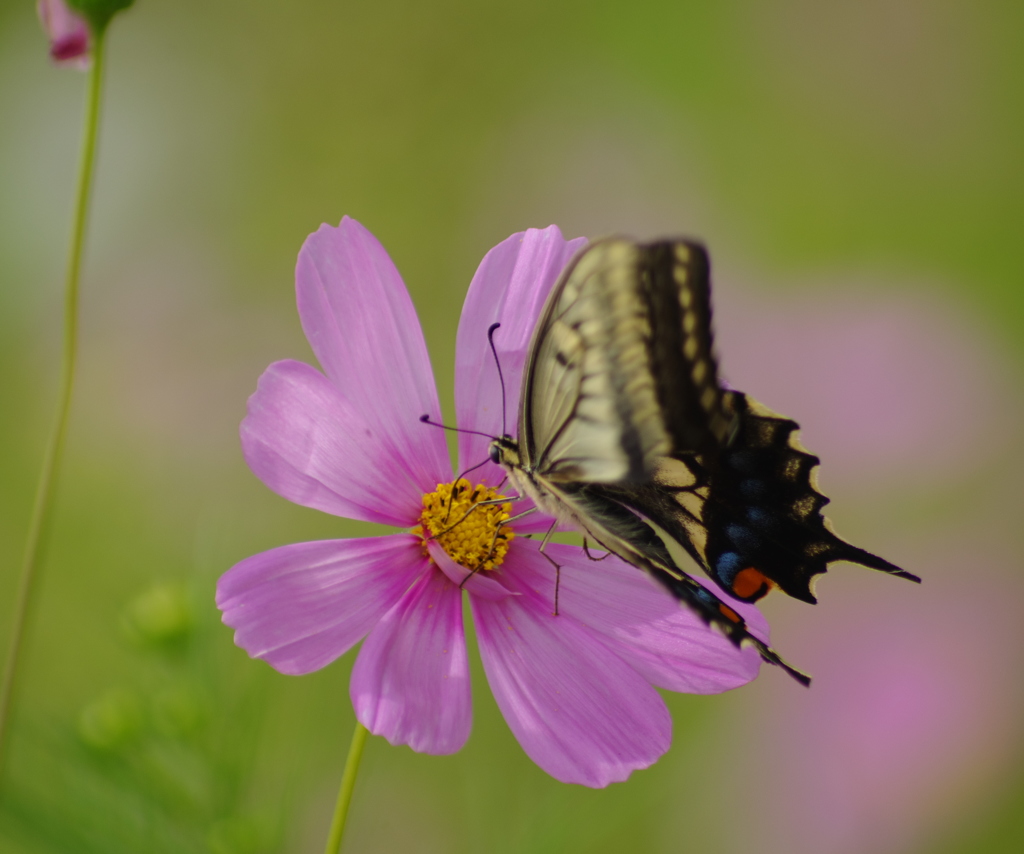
[0,24,104,779]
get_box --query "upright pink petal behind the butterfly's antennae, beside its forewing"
[455,225,587,484]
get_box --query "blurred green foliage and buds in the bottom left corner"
[0,583,287,854]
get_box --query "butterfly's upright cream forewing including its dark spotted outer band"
[519,238,735,483]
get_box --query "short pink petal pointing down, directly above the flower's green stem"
[349,572,472,754]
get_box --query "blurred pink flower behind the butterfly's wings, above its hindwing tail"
[715,286,1015,487]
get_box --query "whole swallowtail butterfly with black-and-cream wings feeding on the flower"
[490,238,920,685]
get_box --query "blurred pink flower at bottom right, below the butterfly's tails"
[732,540,1024,854]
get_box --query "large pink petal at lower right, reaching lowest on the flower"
[471,558,672,788]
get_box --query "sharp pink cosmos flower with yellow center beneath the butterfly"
[217,217,767,786]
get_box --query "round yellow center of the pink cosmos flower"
[413,478,515,571]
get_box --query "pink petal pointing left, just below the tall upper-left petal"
[241,360,423,527]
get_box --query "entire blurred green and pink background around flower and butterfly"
[0,0,1024,854]
